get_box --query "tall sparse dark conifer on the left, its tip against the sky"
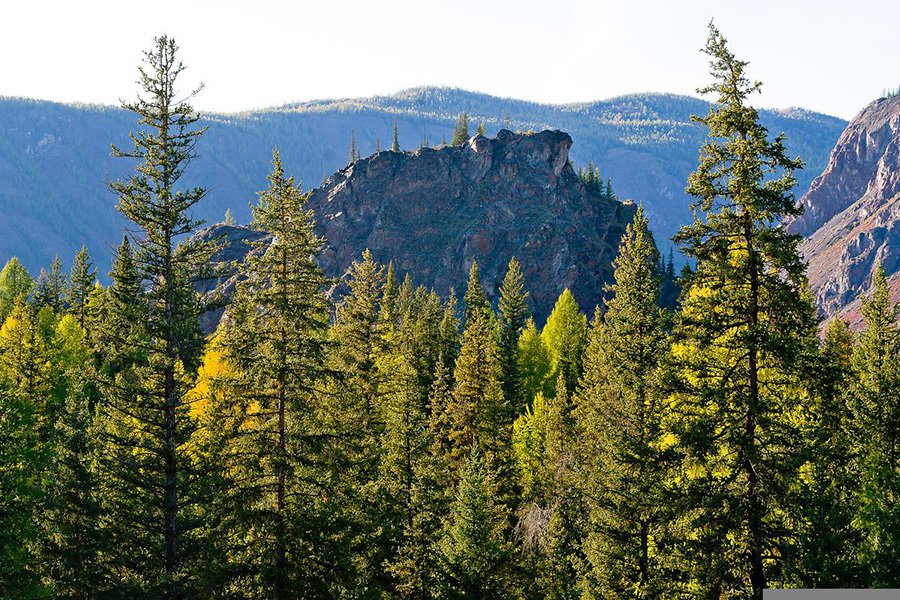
[100,36,213,598]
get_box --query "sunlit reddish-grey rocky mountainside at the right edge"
[788,96,900,315]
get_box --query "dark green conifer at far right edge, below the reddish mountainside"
[851,265,900,587]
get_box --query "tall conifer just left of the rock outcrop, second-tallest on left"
[222,151,330,598]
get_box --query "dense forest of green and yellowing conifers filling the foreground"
[0,25,900,600]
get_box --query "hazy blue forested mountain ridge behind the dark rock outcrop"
[0,87,846,270]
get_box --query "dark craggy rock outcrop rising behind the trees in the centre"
[198,130,634,320]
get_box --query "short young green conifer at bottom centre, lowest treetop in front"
[439,452,515,599]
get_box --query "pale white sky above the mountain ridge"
[0,0,900,119]
